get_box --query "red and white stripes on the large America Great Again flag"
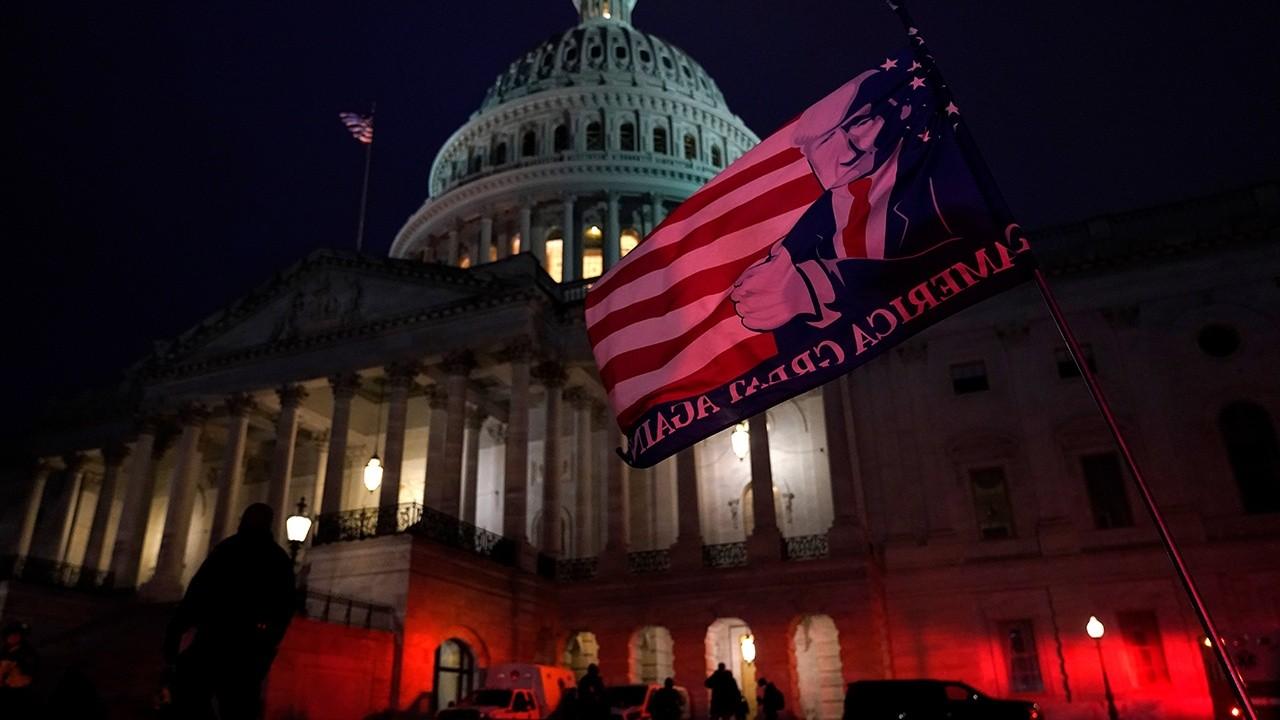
[586,120,823,428]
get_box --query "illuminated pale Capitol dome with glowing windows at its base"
[390,0,759,282]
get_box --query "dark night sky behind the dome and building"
[10,0,1280,423]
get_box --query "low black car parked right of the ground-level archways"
[844,679,1044,720]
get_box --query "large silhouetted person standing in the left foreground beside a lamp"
[164,502,294,720]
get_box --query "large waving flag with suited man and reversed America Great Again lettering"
[586,54,1034,468]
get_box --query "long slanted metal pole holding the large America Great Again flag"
[886,0,1258,720]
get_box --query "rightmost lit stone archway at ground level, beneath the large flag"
[791,615,845,720]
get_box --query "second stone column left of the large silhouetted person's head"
[142,405,207,601]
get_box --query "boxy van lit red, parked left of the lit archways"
[435,662,575,720]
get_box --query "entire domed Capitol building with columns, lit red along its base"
[0,0,1280,720]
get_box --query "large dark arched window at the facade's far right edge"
[1217,402,1280,514]
